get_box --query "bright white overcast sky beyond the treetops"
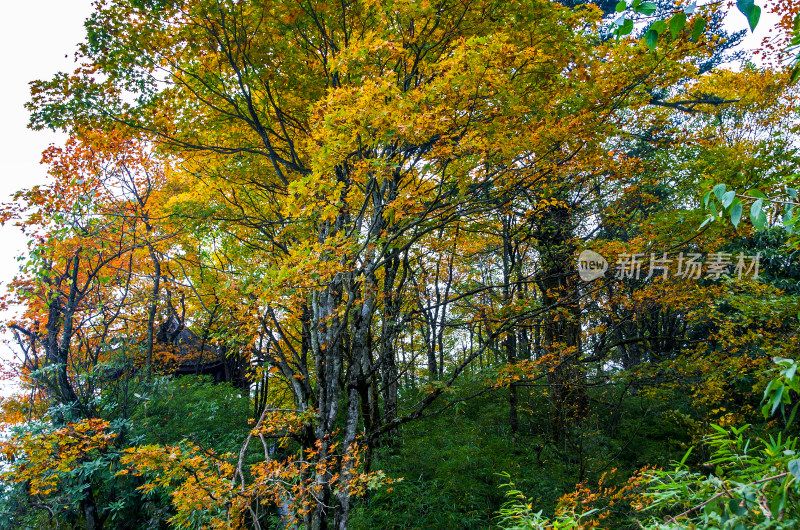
[0,0,774,395]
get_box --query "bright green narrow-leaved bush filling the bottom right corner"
[498,357,800,530]
